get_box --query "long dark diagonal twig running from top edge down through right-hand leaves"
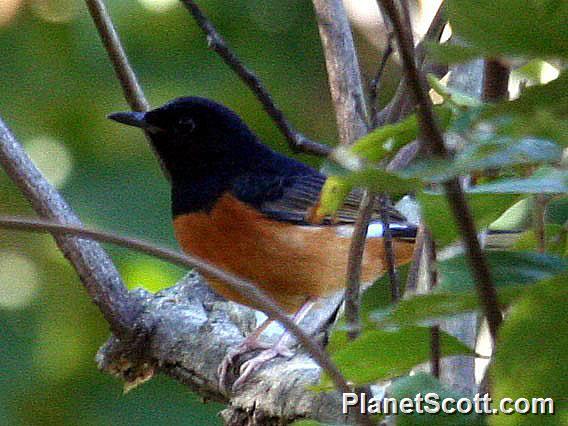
[381,0,502,340]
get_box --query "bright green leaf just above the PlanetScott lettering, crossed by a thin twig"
[321,327,473,388]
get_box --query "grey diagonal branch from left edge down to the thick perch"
[0,119,138,339]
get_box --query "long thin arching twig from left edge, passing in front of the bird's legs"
[0,216,351,398]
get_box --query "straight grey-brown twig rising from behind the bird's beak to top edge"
[85,0,150,112]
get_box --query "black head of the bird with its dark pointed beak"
[109,97,264,181]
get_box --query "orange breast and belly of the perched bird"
[174,194,413,312]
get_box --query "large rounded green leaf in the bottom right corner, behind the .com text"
[491,274,568,426]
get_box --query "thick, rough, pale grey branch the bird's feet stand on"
[97,274,364,426]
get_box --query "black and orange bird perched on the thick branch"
[108,96,416,389]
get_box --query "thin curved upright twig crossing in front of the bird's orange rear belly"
[345,191,376,339]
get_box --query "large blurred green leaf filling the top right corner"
[448,0,568,58]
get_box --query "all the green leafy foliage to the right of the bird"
[310,0,568,424]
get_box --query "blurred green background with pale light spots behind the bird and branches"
[0,0,438,425]
